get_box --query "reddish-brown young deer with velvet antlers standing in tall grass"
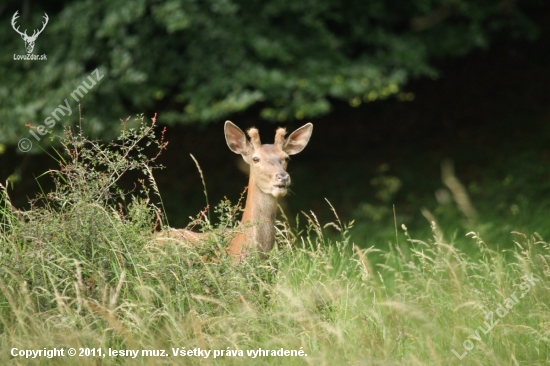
[163,121,313,261]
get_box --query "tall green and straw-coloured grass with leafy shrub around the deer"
[0,119,550,365]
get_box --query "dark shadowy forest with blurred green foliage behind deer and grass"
[0,0,550,245]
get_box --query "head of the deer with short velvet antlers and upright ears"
[224,121,313,198]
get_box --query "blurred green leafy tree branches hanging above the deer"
[0,0,536,143]
